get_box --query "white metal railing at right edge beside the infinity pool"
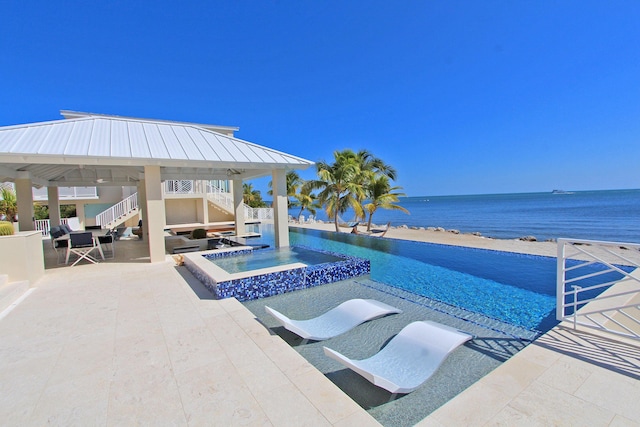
[556,239,640,340]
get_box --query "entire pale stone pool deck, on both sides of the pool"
[0,240,640,426]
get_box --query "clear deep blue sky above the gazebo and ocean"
[0,0,640,196]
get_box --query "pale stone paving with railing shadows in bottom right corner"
[419,325,640,426]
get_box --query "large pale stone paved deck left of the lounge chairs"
[0,242,379,426]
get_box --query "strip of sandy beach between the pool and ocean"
[290,222,640,263]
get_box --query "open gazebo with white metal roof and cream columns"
[0,111,313,262]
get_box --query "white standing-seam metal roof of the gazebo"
[0,112,313,186]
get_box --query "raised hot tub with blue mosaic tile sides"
[184,246,371,301]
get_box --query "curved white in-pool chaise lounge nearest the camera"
[323,321,472,393]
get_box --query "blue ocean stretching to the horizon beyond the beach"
[289,190,640,243]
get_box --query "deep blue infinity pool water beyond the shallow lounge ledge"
[282,228,620,332]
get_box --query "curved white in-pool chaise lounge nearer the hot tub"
[264,299,402,341]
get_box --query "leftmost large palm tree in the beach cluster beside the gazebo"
[307,149,364,232]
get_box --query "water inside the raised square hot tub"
[209,247,343,273]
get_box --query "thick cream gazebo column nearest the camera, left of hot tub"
[142,166,165,262]
